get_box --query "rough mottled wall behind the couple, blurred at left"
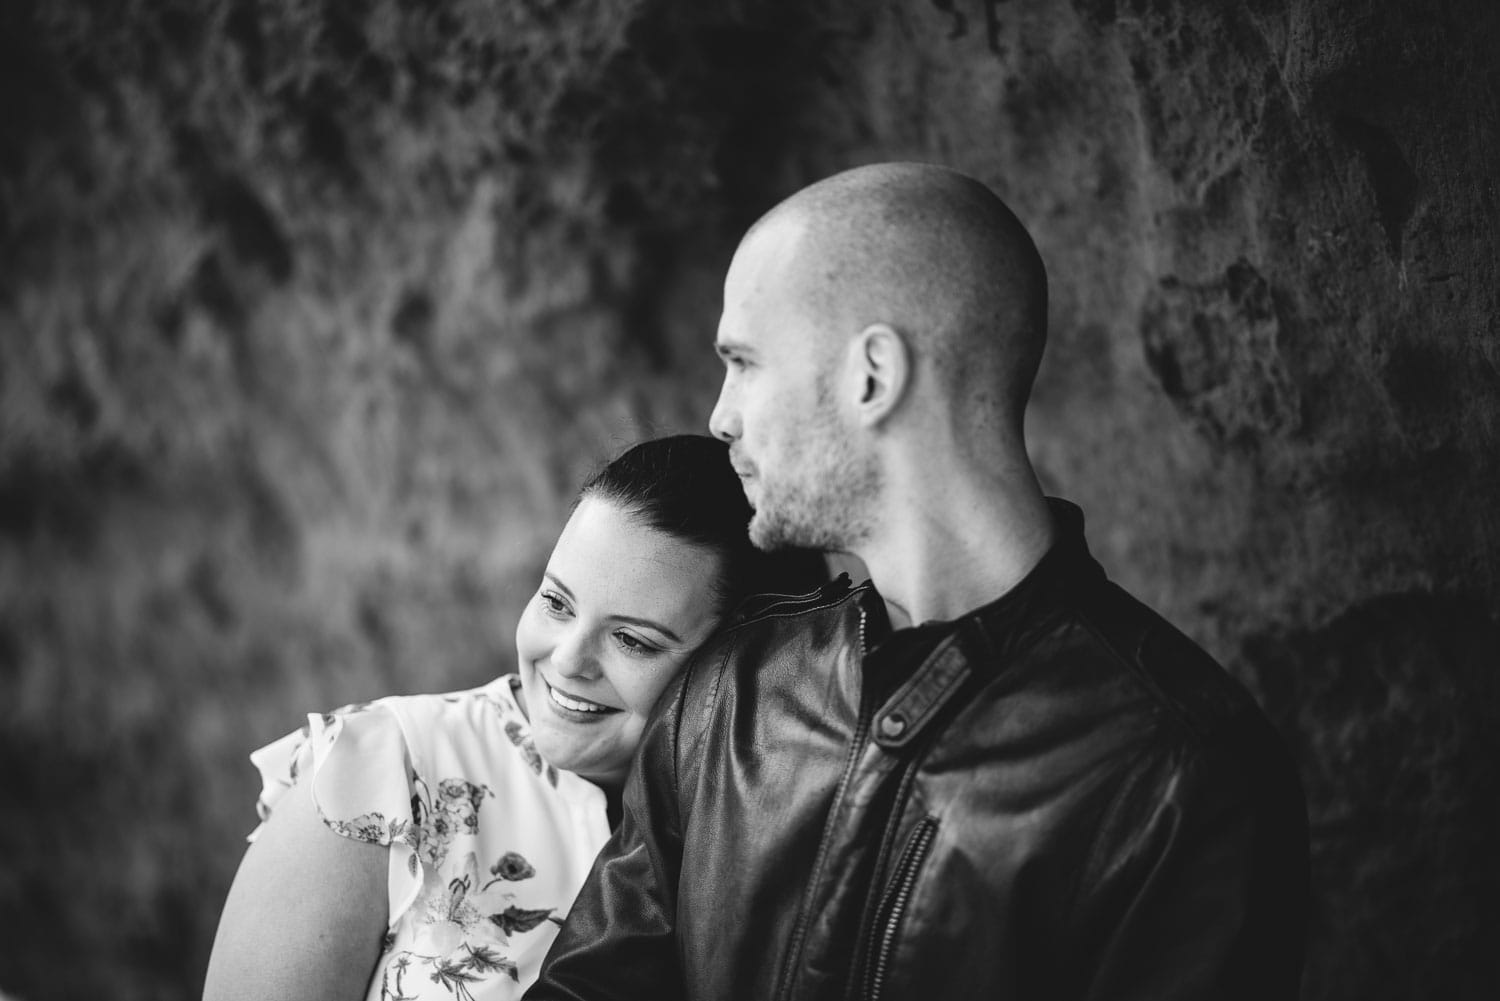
[0,0,1500,1001]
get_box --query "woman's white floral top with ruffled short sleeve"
[251,675,609,1001]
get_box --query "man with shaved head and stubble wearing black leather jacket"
[527,164,1308,1001]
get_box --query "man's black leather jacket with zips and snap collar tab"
[527,501,1308,1001]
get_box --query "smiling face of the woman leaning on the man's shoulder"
[516,497,720,788]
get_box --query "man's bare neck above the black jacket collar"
[858,480,1055,629]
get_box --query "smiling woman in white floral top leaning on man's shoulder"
[204,435,825,1001]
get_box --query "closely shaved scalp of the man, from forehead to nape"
[741,164,1047,431]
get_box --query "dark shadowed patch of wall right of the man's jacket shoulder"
[1247,593,1500,998]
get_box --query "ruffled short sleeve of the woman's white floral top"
[249,702,422,927]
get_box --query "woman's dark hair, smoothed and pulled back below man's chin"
[573,435,828,611]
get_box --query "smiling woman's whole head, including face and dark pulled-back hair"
[516,435,827,797]
